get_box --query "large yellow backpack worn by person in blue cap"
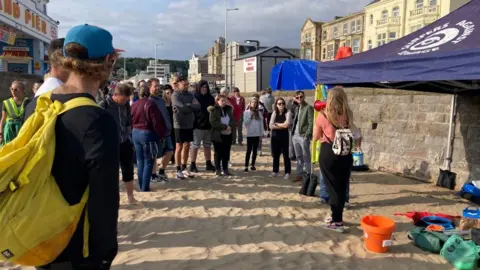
[0,92,98,266]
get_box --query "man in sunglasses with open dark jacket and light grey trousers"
[292,91,313,182]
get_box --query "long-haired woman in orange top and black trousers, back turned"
[313,87,360,232]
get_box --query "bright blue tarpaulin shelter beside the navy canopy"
[270,60,318,91]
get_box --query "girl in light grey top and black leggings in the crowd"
[243,98,265,172]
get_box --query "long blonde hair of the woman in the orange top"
[325,87,353,127]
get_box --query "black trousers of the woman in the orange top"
[320,143,353,222]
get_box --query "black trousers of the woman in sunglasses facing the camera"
[271,129,292,174]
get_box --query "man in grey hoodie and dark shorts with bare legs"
[170,74,201,179]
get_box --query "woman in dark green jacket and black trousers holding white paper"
[208,95,235,177]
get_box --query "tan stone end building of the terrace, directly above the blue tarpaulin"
[298,18,323,61]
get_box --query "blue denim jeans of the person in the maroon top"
[132,129,158,192]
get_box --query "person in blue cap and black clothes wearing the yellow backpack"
[29,24,120,270]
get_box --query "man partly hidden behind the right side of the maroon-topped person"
[148,78,173,183]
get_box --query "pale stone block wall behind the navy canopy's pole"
[270,88,480,188]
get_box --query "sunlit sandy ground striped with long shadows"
[0,140,466,270]
